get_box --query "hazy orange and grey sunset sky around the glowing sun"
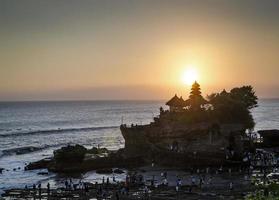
[0,0,279,101]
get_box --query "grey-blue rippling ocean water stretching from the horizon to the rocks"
[0,99,279,193]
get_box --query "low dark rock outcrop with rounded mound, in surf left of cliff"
[25,145,145,173]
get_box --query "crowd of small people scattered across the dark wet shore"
[21,148,277,200]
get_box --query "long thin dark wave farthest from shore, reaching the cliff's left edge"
[0,126,119,138]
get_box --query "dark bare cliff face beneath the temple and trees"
[121,122,244,165]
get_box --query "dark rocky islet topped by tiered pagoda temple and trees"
[121,82,256,165]
